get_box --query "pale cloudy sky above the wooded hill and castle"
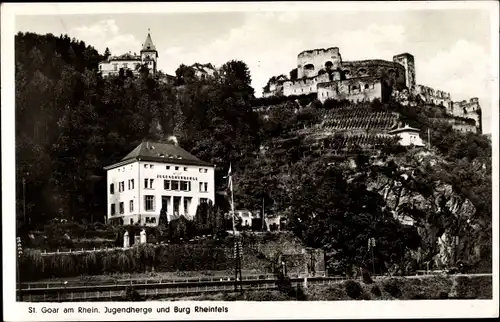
[15,9,498,133]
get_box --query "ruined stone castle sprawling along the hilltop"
[263,47,482,133]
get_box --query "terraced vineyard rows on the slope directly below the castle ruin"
[320,107,398,131]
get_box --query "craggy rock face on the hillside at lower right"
[350,152,479,269]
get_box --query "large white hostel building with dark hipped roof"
[104,142,215,226]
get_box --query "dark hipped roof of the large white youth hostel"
[104,141,213,170]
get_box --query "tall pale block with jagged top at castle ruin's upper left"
[297,47,342,78]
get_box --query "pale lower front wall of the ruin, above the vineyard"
[318,77,383,103]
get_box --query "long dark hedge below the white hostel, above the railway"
[20,244,234,281]
